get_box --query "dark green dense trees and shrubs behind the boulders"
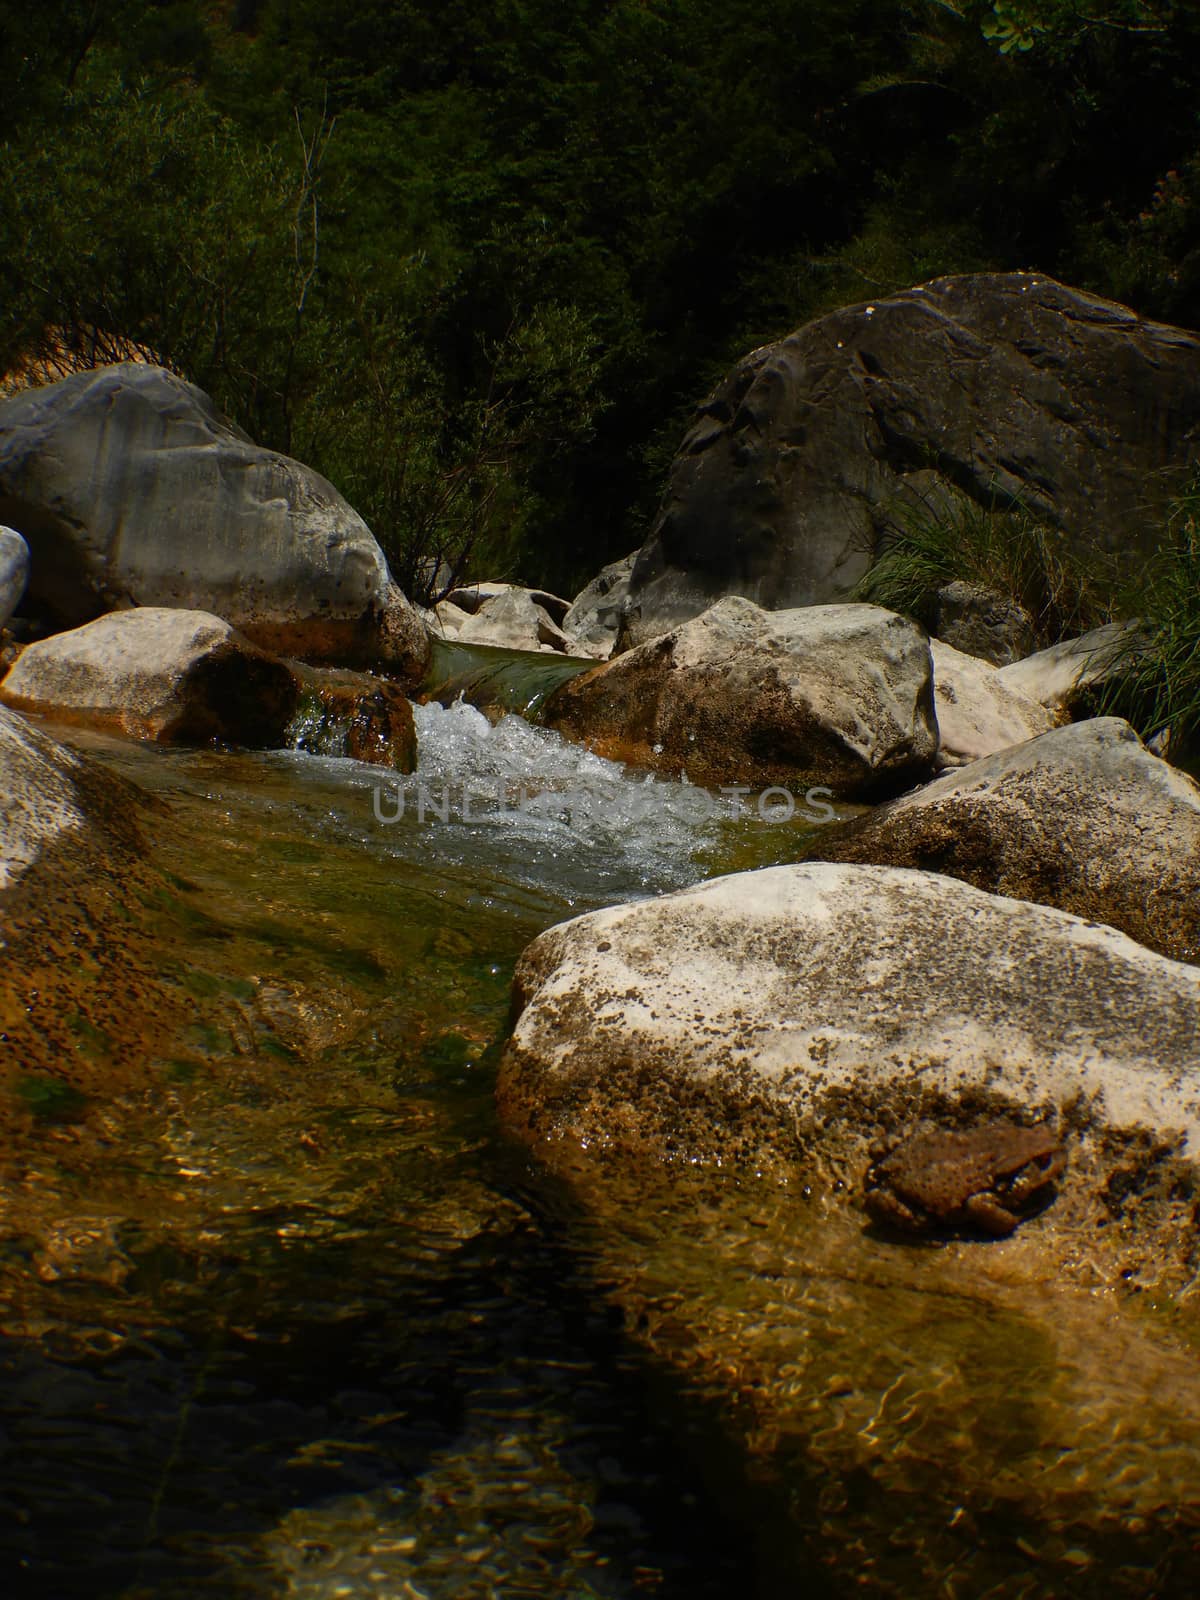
[0,0,1200,590]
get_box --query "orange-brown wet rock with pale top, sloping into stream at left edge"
[0,707,194,1100]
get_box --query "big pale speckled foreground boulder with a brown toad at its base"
[498,864,1200,1196]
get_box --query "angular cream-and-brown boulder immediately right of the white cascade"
[542,595,938,795]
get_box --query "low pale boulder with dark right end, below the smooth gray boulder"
[0,606,299,747]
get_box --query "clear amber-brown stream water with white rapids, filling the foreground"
[0,707,1200,1600]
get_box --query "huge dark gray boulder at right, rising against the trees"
[626,272,1200,643]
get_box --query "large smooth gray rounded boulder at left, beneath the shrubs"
[0,362,429,678]
